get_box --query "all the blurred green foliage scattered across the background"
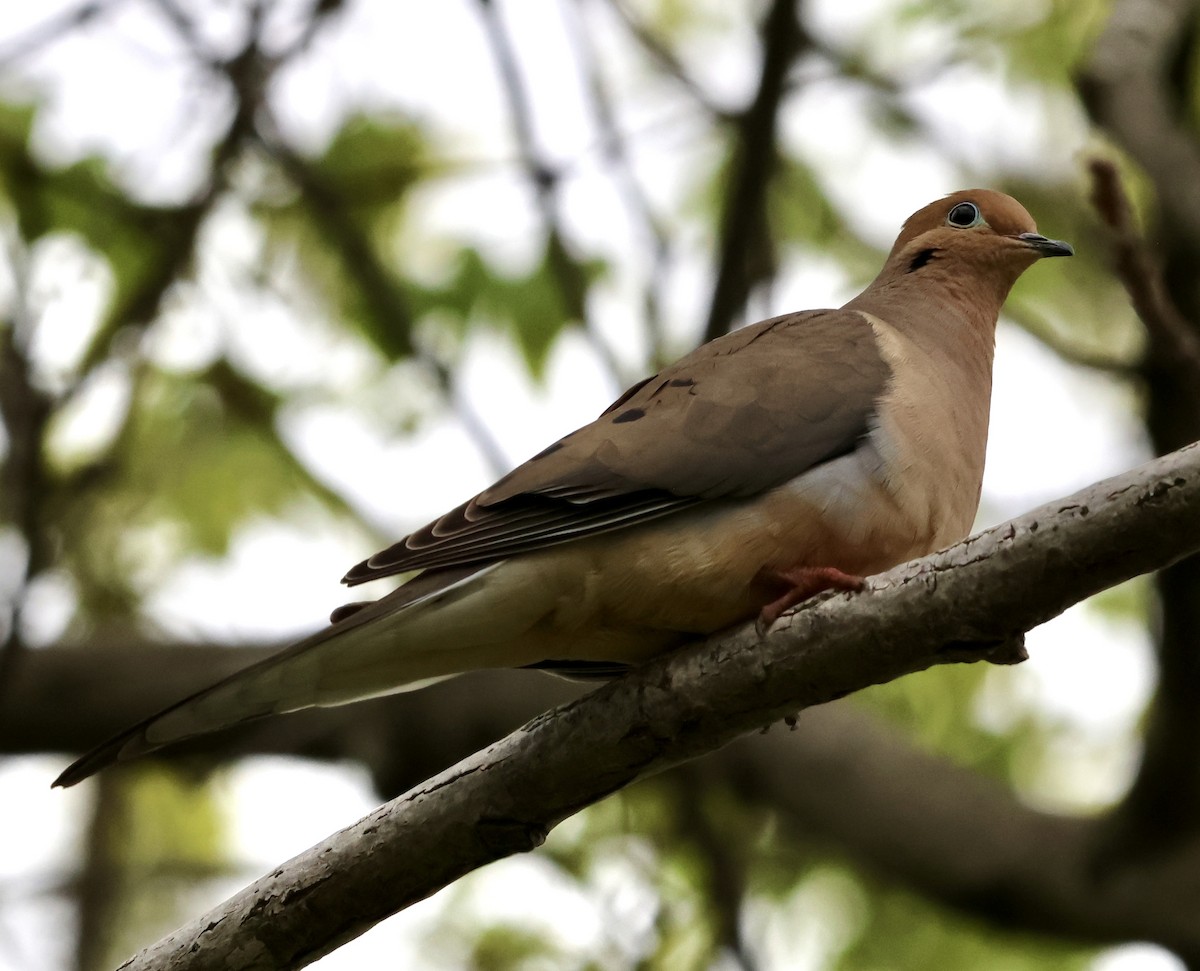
[0,0,1171,971]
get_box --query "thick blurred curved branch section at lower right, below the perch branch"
[729,705,1200,957]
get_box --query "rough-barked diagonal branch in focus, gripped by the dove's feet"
[122,445,1200,971]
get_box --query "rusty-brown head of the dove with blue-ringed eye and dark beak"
[851,188,1074,326]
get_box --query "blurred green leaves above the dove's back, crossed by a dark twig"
[256,108,604,376]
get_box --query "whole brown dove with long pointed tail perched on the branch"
[54,188,1074,786]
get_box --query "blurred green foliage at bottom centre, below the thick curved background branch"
[530,779,1091,971]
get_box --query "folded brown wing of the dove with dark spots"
[343,311,890,585]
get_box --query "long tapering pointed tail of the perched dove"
[53,567,492,786]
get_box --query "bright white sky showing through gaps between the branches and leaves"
[0,0,1178,971]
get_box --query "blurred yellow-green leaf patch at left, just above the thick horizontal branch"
[47,360,344,621]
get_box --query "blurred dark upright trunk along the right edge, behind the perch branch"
[1079,0,1200,852]
